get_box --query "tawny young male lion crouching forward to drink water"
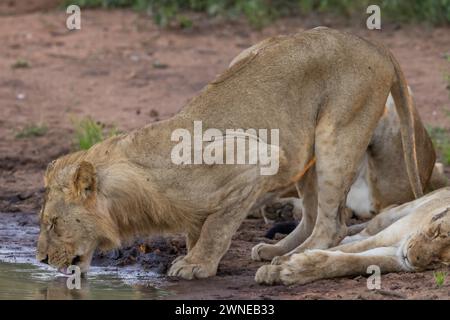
[37,28,422,279]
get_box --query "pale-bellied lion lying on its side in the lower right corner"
[255,187,450,285]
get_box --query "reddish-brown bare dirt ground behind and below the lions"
[0,0,450,299]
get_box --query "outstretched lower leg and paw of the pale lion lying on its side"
[255,247,403,285]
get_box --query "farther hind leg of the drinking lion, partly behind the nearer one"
[252,166,317,261]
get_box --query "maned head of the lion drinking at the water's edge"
[36,146,183,273]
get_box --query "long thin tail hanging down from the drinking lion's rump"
[388,51,423,198]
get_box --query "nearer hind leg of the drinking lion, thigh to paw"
[272,87,389,264]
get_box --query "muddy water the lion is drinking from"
[0,213,169,300]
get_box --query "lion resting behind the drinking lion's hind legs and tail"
[260,89,447,226]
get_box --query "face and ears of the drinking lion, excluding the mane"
[37,158,108,273]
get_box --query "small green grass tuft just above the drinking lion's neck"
[72,117,119,150]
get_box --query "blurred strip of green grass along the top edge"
[64,0,450,28]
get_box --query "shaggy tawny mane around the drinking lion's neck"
[45,136,203,249]
